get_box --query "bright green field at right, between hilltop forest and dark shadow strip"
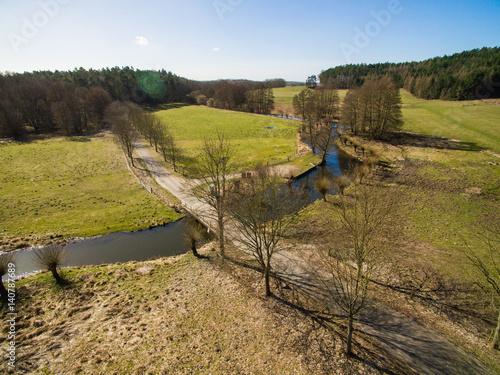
[401,90,500,153]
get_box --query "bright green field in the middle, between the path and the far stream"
[156,106,298,169]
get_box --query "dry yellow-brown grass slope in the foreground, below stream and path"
[0,247,400,375]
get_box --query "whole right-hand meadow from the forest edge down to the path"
[292,91,500,371]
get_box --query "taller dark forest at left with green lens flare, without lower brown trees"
[0,67,194,138]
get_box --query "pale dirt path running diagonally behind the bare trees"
[136,144,491,375]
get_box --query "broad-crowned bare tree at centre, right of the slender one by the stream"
[229,167,303,296]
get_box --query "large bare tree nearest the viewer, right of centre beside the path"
[313,185,391,355]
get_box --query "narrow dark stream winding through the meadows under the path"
[6,131,355,276]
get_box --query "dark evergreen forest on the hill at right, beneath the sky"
[319,47,500,100]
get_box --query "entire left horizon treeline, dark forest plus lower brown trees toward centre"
[0,67,286,138]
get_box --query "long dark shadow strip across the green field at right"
[382,131,484,152]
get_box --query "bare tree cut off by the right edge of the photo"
[465,220,500,349]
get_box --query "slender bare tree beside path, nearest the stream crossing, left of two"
[194,132,236,256]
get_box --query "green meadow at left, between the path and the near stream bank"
[0,134,179,250]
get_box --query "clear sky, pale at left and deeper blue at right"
[0,0,500,81]
